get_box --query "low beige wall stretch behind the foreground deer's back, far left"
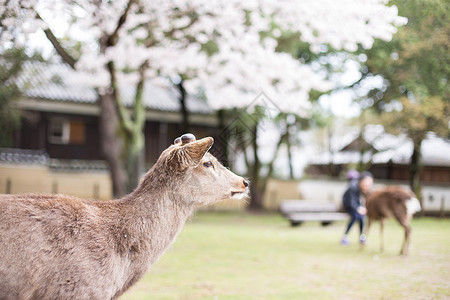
[0,164,112,200]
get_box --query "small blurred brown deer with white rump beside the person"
[366,186,421,255]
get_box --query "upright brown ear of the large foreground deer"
[178,137,214,167]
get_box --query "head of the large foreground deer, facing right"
[157,134,249,206]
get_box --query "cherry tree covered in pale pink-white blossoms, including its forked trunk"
[0,0,405,202]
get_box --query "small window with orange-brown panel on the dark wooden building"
[48,118,85,144]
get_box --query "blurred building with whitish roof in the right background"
[306,125,450,186]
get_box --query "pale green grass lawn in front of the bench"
[121,212,450,300]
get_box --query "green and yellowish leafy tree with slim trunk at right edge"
[360,0,450,197]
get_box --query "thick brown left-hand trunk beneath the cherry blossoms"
[99,94,127,198]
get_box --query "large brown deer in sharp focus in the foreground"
[0,134,249,300]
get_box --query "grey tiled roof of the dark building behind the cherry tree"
[17,62,213,114]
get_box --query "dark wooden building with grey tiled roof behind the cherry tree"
[9,62,218,165]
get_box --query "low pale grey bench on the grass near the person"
[280,200,349,226]
